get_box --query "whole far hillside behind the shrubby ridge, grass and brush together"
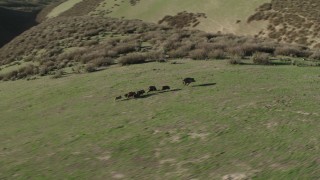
[43,0,320,48]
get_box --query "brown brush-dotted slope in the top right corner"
[248,0,320,49]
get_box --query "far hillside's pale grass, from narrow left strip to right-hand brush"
[41,0,269,35]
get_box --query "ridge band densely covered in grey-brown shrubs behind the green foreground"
[0,16,318,80]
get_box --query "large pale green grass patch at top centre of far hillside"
[97,0,270,34]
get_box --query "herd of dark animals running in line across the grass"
[115,78,196,101]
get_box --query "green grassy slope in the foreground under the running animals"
[0,60,320,179]
